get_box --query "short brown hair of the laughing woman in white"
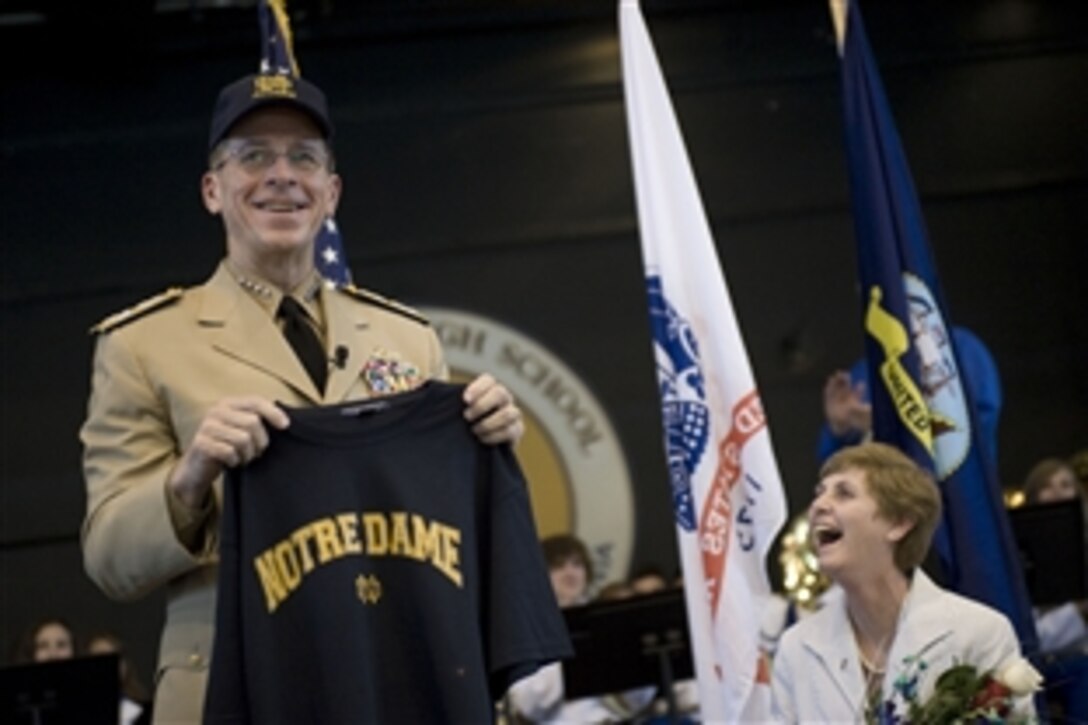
[819,443,941,574]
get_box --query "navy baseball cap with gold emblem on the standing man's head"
[208,73,333,151]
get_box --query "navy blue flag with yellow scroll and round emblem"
[842,0,1037,654]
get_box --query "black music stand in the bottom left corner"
[0,654,121,725]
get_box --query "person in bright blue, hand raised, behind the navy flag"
[817,327,1002,462]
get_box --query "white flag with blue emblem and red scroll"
[619,0,787,723]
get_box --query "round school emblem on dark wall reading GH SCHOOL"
[419,307,634,583]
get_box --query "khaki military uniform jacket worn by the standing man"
[81,265,446,723]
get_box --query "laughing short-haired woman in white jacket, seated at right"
[771,443,1037,723]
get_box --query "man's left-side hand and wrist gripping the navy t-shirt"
[166,396,290,508]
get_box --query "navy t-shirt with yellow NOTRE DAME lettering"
[205,382,571,725]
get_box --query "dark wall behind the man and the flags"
[0,0,1088,687]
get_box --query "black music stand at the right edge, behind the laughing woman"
[1009,500,1088,605]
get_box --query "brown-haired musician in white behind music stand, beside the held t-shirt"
[507,534,656,724]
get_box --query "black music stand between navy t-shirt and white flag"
[562,589,694,722]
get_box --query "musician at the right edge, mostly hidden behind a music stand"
[1024,458,1088,723]
